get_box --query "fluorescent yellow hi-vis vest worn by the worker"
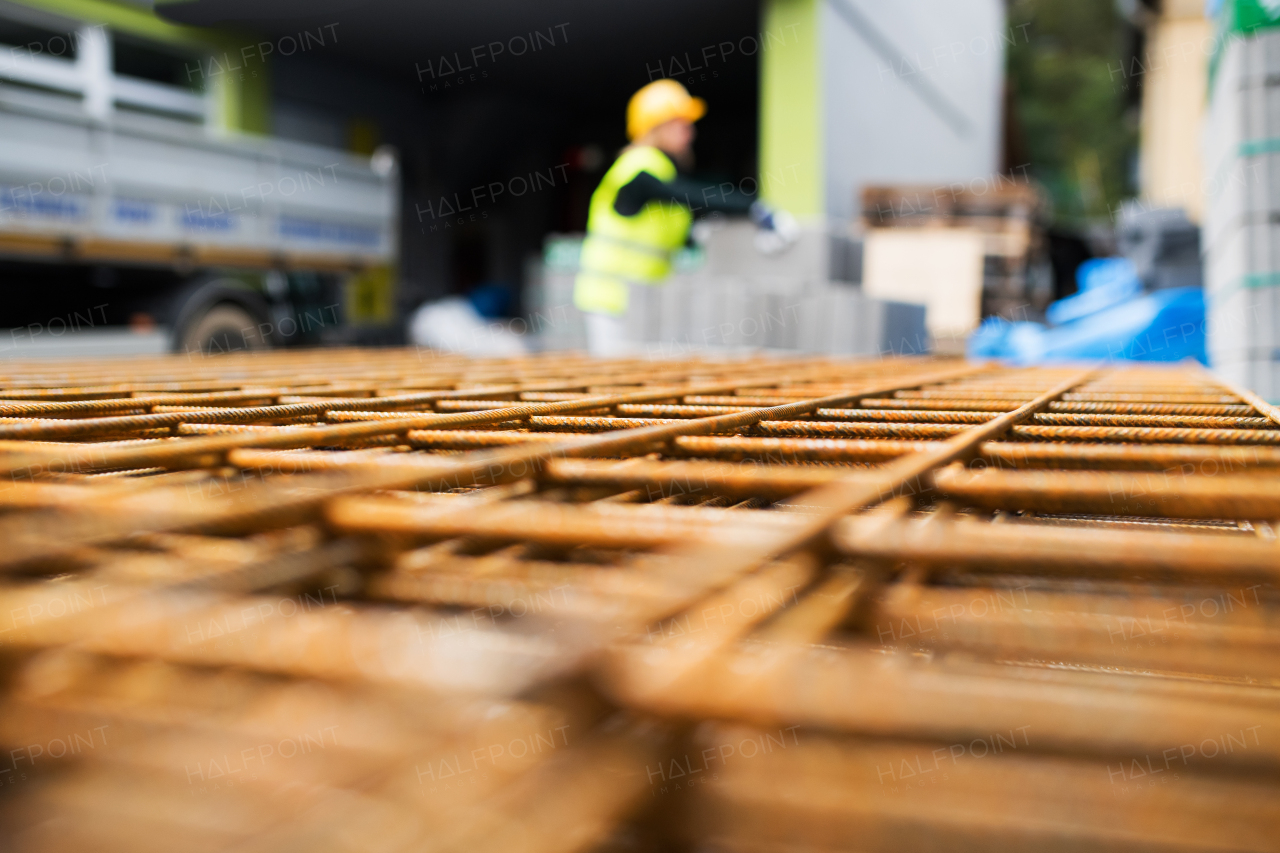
[573,147,694,316]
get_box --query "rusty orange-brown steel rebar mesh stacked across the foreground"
[0,350,1280,853]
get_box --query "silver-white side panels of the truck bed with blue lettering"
[0,90,398,270]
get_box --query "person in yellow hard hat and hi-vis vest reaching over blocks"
[573,79,797,356]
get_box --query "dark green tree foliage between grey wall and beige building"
[1009,0,1140,223]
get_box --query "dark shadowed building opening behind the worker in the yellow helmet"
[157,0,759,320]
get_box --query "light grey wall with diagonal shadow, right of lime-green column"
[820,0,1008,222]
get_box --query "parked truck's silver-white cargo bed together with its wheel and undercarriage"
[0,81,399,352]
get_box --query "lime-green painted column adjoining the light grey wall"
[760,0,826,219]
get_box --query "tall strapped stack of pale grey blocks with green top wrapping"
[1203,0,1280,400]
